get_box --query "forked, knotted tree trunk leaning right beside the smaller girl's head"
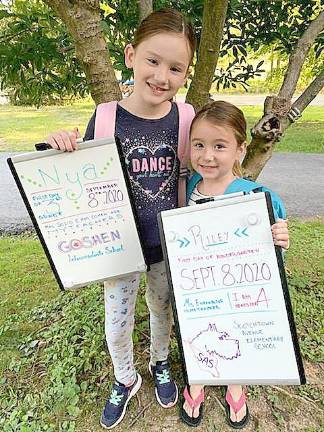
[242,12,324,180]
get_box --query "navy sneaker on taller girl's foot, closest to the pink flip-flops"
[149,360,178,408]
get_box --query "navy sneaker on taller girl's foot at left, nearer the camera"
[100,373,142,429]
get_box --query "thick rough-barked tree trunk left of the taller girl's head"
[43,0,121,104]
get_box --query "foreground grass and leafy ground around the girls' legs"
[0,220,324,432]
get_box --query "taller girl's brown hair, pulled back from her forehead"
[132,8,196,65]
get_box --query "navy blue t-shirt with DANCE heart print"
[84,103,179,264]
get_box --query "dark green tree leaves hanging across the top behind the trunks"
[0,0,324,106]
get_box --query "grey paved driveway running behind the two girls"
[0,153,324,234]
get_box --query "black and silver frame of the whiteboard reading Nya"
[7,136,148,291]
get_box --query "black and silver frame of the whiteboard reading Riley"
[158,192,306,385]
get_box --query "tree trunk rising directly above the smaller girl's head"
[186,0,228,110]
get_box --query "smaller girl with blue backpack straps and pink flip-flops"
[180,101,289,429]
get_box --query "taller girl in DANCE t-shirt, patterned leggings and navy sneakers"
[48,9,195,428]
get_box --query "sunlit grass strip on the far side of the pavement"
[0,101,324,153]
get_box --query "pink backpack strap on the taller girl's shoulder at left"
[94,101,117,138]
